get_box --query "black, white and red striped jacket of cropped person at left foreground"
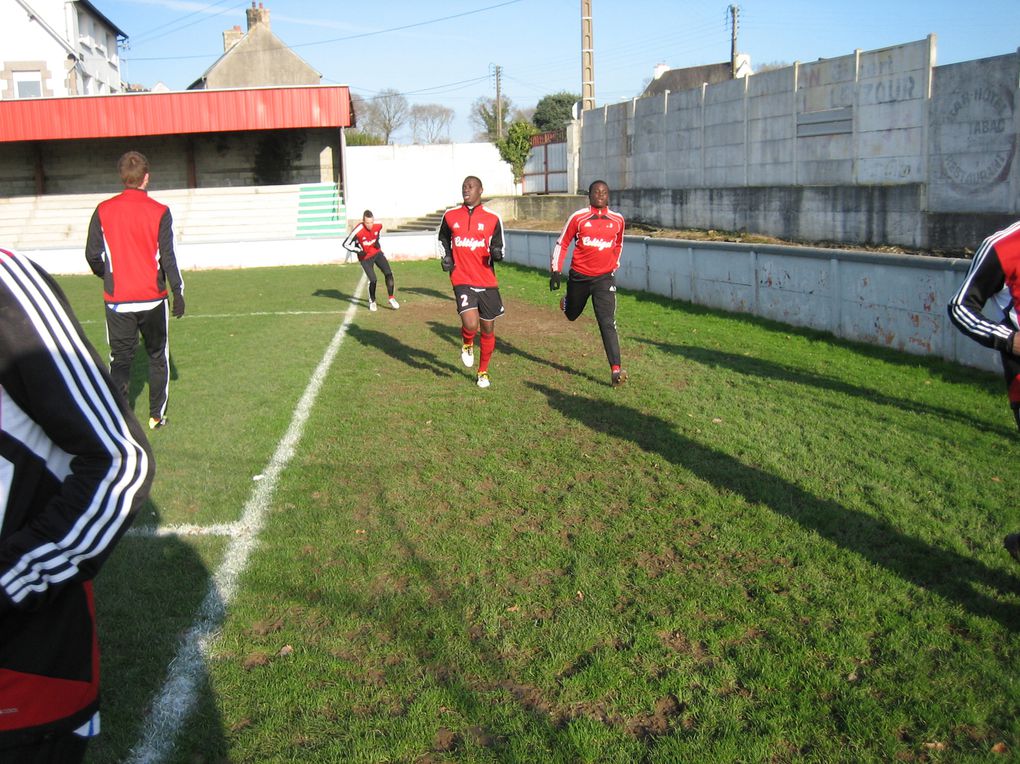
[0,250,154,746]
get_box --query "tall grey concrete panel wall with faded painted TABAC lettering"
[578,36,1020,250]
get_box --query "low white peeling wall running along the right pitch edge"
[506,231,1001,370]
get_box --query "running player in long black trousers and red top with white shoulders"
[549,181,627,388]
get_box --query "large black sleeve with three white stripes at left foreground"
[0,250,154,612]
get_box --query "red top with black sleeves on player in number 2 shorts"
[439,204,503,287]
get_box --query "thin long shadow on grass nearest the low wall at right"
[631,337,1015,438]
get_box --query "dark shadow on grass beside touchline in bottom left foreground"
[86,501,227,764]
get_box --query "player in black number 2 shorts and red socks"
[439,175,503,388]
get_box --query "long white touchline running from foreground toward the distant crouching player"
[128,275,368,764]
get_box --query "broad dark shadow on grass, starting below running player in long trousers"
[525,383,1020,630]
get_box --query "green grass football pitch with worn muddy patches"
[51,262,1020,762]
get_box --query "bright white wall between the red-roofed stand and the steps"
[344,143,514,225]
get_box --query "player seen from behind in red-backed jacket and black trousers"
[85,151,185,429]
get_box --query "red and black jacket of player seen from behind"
[85,189,185,305]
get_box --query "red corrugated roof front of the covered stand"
[0,85,351,143]
